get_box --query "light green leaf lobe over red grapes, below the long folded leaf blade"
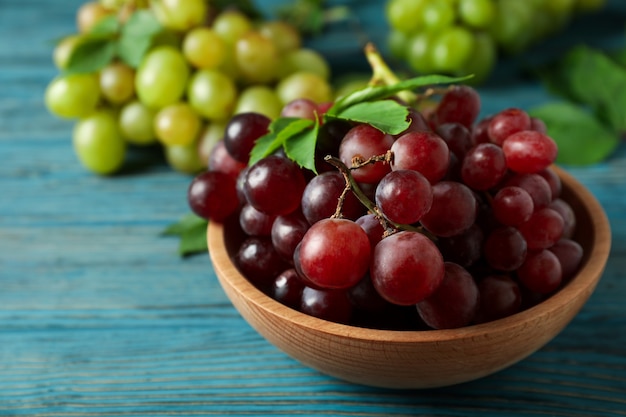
[337,100,409,135]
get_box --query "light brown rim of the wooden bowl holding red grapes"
[207,165,611,343]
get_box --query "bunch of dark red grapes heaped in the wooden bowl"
[188,85,583,329]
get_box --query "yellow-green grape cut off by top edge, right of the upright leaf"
[150,0,208,32]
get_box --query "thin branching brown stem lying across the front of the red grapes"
[324,151,437,242]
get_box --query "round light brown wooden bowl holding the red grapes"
[207,167,611,388]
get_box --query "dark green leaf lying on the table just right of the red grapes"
[529,102,620,165]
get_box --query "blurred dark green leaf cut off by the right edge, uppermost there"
[539,46,626,132]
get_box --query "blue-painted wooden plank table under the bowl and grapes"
[0,0,626,417]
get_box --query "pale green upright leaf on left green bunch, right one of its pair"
[117,10,163,68]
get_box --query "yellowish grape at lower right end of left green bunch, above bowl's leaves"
[276,71,333,105]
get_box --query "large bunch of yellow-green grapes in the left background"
[45,0,333,175]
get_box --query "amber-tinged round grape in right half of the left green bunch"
[235,31,278,84]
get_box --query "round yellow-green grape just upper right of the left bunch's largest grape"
[183,27,226,68]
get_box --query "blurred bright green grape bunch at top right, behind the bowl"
[385,0,605,83]
